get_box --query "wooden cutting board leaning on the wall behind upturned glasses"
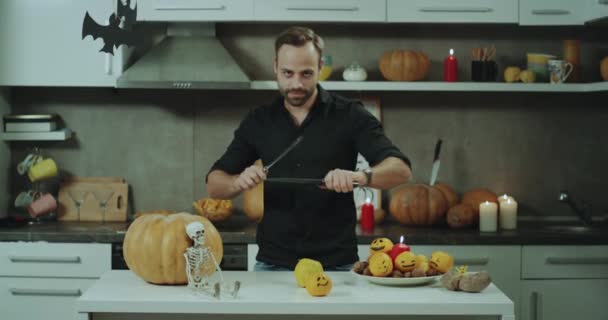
[57,177,129,221]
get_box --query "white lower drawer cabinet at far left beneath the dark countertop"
[0,242,111,320]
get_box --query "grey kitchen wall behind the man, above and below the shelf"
[0,25,608,221]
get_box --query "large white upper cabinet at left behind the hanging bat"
[0,0,124,87]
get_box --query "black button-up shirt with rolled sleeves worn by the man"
[210,86,410,268]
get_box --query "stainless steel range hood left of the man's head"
[116,24,251,89]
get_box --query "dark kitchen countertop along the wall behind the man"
[0,216,608,245]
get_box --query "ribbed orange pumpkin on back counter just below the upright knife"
[389,184,448,225]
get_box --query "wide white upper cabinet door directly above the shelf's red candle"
[386,0,519,23]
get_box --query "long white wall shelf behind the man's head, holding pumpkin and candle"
[251,80,608,92]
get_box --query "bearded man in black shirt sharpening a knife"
[207,27,411,270]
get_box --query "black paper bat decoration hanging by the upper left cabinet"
[82,0,139,55]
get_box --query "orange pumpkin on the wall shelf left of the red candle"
[380,50,431,81]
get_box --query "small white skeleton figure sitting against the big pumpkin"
[184,221,241,299]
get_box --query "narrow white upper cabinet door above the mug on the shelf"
[519,0,586,25]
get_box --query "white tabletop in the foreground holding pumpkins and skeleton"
[76,270,515,320]
